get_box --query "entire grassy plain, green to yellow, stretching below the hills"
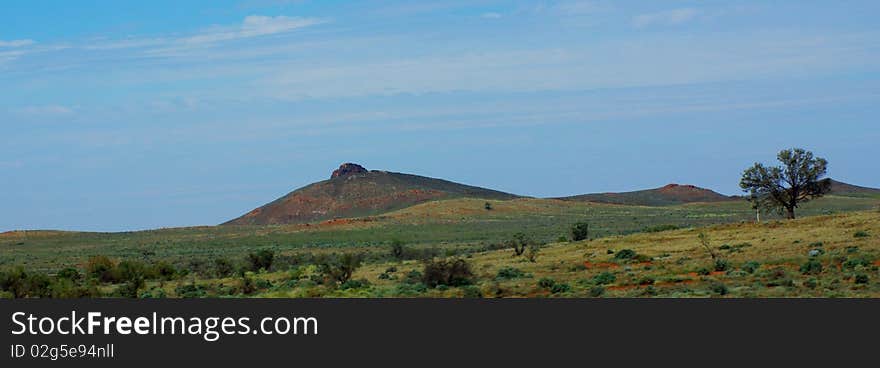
[0,196,880,297]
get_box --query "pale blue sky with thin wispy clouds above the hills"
[0,0,880,231]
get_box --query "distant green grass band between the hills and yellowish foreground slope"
[0,197,880,272]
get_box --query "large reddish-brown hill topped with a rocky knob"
[223,163,518,225]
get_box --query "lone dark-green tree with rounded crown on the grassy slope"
[739,148,831,219]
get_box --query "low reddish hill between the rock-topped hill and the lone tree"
[559,184,735,206]
